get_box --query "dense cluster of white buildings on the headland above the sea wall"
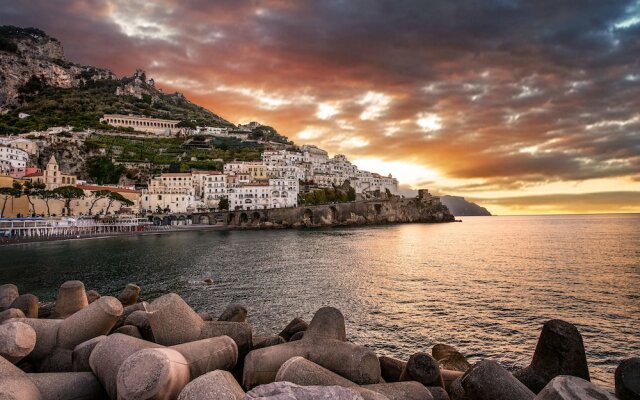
[140,145,398,212]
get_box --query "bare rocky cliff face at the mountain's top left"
[0,26,116,113]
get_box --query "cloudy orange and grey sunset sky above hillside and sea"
[0,0,640,214]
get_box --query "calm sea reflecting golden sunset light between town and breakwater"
[0,215,640,387]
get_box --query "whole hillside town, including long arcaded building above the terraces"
[0,114,398,218]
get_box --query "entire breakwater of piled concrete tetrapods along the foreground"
[0,281,640,400]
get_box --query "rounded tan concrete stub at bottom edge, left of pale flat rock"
[178,369,244,400]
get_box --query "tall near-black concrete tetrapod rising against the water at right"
[514,319,589,393]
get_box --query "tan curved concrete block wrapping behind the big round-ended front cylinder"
[89,333,162,399]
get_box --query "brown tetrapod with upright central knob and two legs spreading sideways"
[243,307,380,389]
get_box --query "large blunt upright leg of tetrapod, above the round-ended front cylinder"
[148,293,204,346]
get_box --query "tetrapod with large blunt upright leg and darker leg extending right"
[147,293,253,354]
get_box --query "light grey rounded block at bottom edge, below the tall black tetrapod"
[535,375,616,400]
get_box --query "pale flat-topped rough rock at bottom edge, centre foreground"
[245,382,364,400]
